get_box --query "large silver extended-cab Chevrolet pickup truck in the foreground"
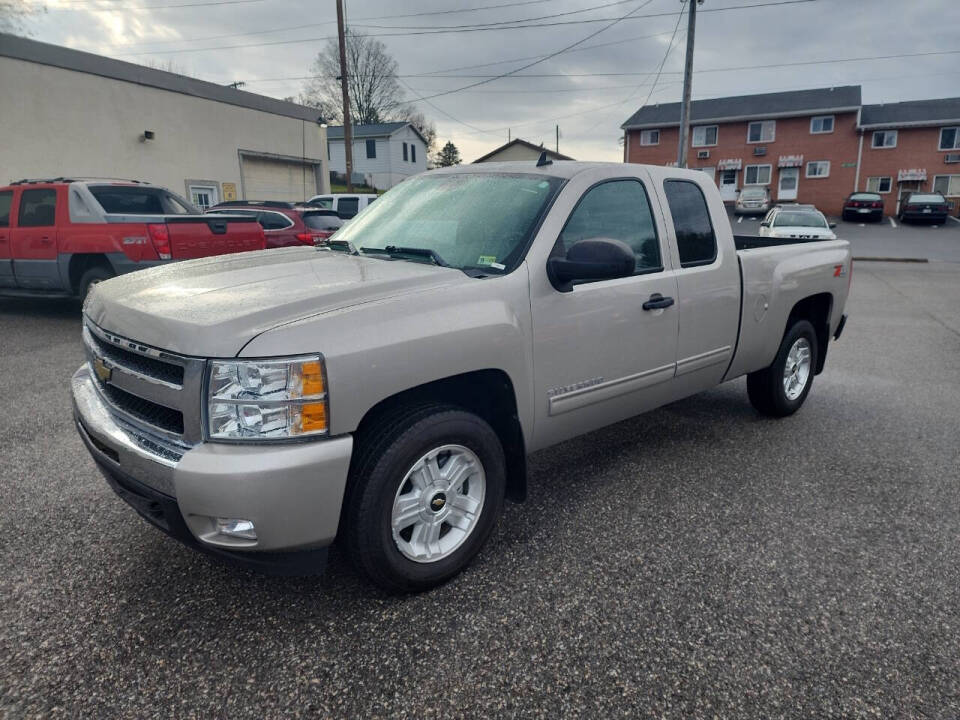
[72,162,851,591]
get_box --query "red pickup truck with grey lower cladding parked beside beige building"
[0,178,265,299]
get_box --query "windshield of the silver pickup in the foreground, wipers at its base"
[337,173,563,274]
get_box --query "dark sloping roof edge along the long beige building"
[0,33,322,122]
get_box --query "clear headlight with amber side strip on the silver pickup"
[207,355,328,440]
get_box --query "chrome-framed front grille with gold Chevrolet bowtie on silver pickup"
[83,319,206,450]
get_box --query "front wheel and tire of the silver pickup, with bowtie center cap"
[344,405,506,592]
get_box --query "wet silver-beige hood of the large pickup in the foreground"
[84,247,469,357]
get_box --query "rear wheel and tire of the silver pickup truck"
[747,320,819,417]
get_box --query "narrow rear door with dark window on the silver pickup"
[660,176,740,395]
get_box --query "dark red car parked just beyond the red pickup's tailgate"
[207,200,343,248]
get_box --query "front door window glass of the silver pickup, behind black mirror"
[558,180,663,274]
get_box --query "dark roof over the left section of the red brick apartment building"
[620,85,860,130]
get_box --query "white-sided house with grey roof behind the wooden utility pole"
[327,122,427,190]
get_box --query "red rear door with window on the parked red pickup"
[10,188,62,290]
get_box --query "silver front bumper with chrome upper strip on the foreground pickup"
[72,365,353,568]
